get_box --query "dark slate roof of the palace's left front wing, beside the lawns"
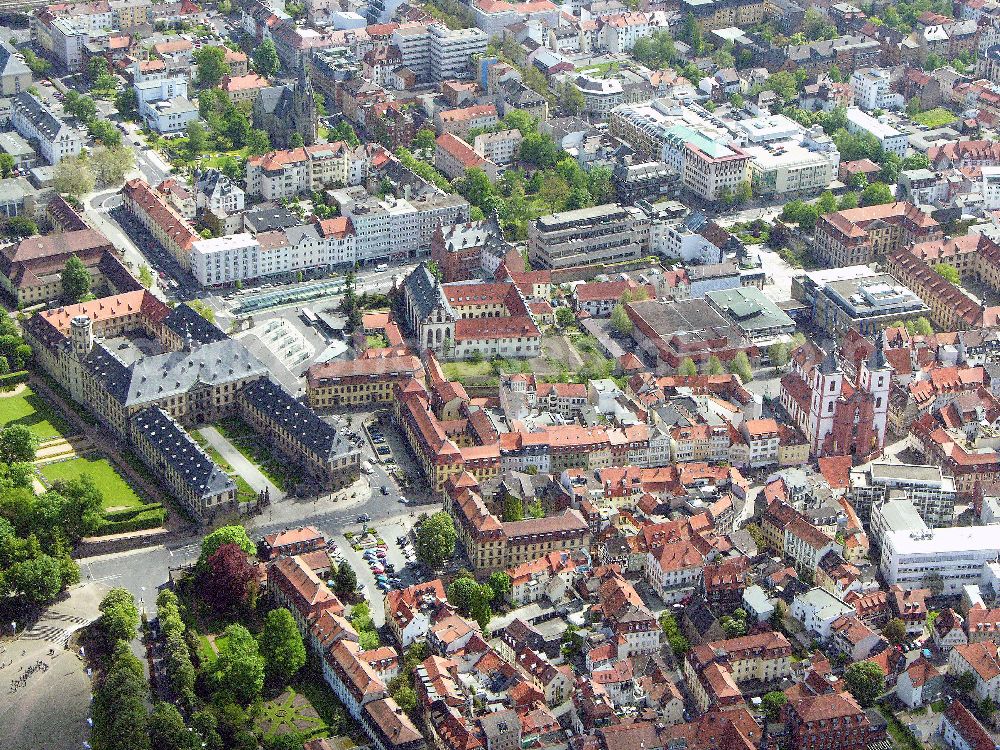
[132,407,236,497]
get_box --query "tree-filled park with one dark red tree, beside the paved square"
[78,525,366,750]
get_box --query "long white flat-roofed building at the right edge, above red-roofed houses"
[879,526,1000,595]
